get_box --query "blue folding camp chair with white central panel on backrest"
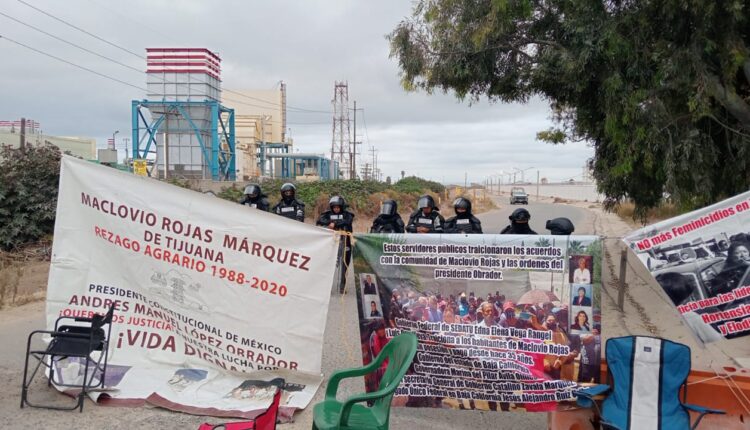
[575,336,724,430]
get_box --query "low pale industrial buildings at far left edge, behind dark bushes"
[0,119,96,160]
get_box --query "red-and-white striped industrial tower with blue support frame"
[131,48,236,181]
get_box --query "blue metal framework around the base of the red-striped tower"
[131,100,237,181]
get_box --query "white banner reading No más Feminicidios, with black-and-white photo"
[623,192,750,356]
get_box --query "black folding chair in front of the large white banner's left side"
[21,305,115,412]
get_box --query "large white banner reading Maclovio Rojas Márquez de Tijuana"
[47,157,337,417]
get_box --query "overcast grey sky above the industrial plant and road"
[0,0,593,183]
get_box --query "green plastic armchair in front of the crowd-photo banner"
[313,332,417,430]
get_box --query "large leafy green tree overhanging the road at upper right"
[389,0,750,221]
